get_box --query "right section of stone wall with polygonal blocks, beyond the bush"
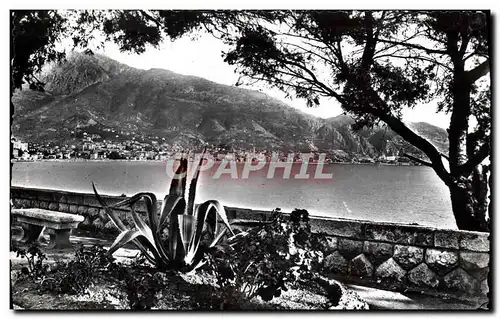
[312,218,490,302]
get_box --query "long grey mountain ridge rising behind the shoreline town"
[12,53,447,160]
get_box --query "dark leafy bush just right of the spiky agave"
[210,208,322,308]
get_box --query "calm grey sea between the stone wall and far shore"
[11,161,457,229]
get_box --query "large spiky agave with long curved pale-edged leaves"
[92,152,239,272]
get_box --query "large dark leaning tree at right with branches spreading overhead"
[11,10,491,231]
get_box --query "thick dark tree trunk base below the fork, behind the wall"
[450,177,489,232]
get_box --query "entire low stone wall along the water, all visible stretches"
[11,187,490,302]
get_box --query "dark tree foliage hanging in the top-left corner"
[10,10,108,94]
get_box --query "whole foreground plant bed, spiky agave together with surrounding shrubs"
[9,158,368,310]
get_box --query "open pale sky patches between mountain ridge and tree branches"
[100,29,449,128]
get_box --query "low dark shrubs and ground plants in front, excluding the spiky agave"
[11,210,366,310]
